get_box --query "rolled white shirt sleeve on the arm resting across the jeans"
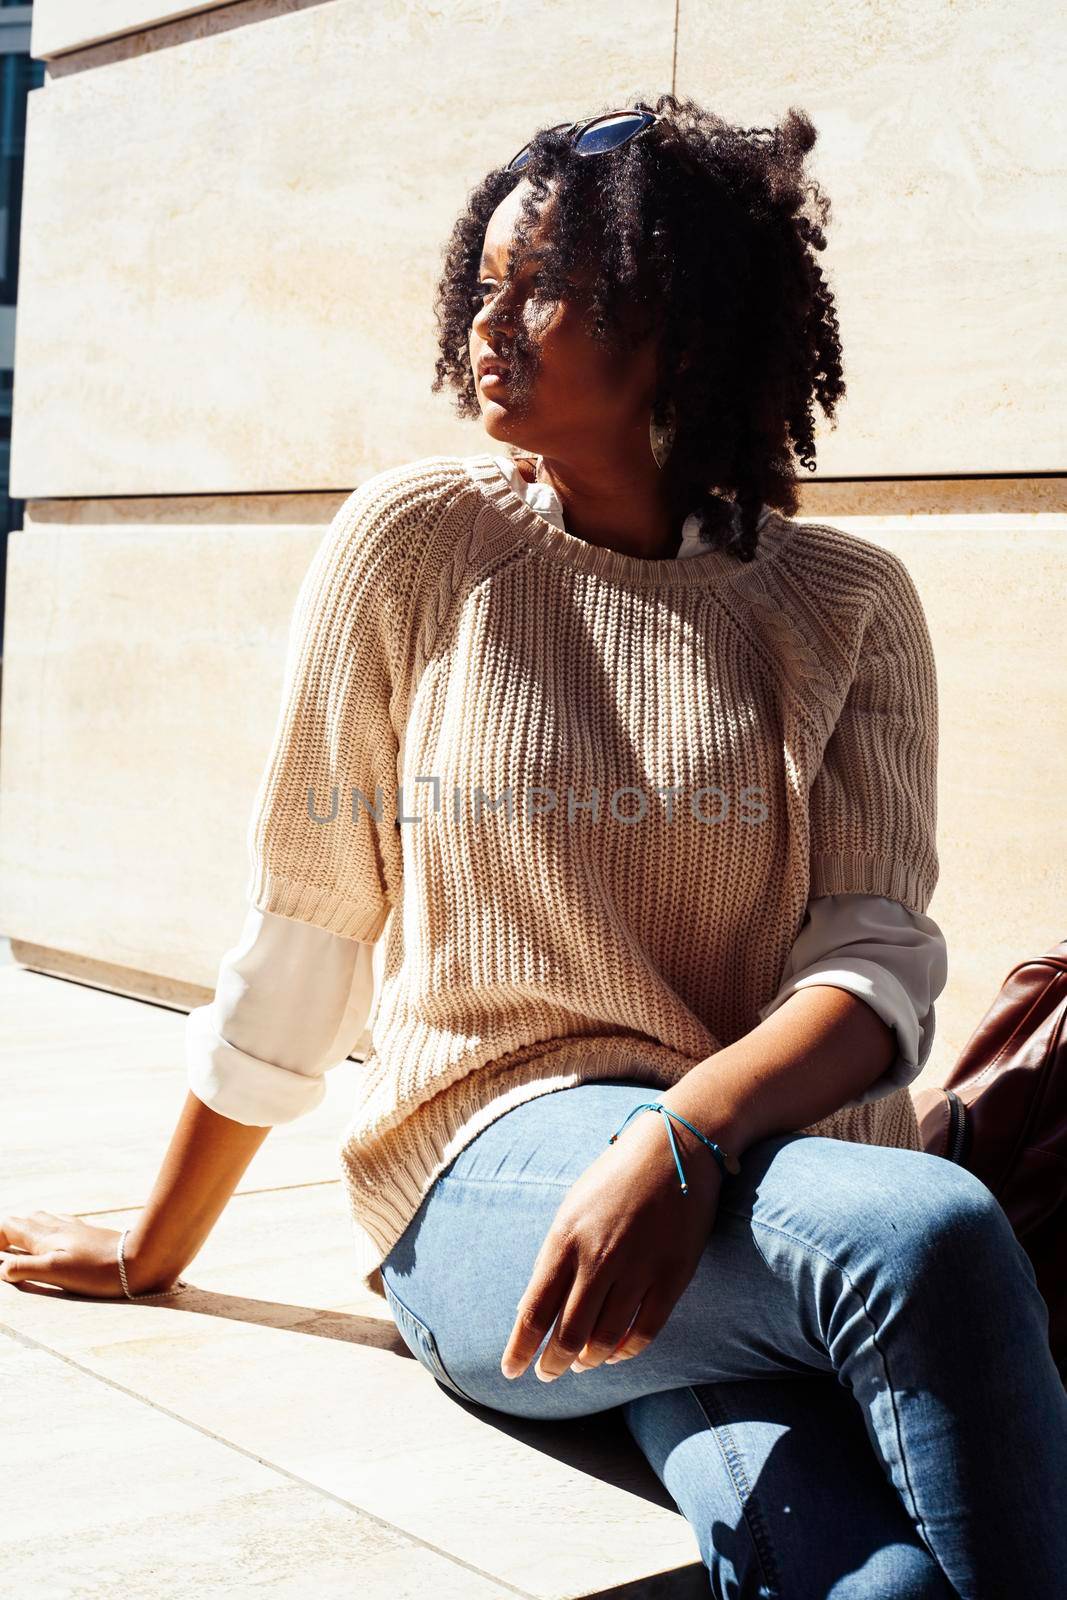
[757,894,949,1106]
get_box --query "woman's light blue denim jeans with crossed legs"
[382,1078,1067,1600]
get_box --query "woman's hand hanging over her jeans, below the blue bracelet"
[501,1096,721,1381]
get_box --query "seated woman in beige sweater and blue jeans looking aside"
[2,96,1067,1600]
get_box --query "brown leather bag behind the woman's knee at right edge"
[942,939,1067,1382]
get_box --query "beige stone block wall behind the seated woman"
[0,0,1067,1075]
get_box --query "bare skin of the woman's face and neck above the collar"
[470,179,681,558]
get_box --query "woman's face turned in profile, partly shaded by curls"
[470,179,656,462]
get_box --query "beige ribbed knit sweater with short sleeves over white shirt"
[248,454,937,1294]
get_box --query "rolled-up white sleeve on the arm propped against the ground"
[186,906,374,1128]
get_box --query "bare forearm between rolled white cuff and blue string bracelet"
[659,984,896,1162]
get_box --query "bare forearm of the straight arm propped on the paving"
[123,1090,270,1294]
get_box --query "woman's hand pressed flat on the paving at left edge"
[0,1211,178,1299]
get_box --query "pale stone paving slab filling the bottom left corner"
[0,1338,515,1600]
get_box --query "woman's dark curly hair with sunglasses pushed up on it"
[432,94,845,562]
